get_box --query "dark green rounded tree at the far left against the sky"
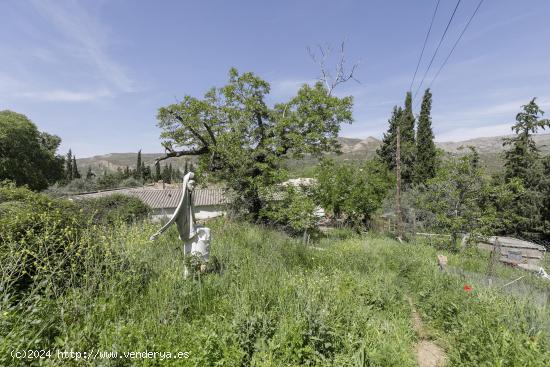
[0,111,64,190]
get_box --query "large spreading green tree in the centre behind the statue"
[158,68,353,219]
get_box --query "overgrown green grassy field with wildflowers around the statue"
[4,220,550,366]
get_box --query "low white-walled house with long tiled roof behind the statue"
[70,187,229,220]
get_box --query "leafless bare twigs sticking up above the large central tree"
[307,41,361,95]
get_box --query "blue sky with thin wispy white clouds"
[0,0,550,157]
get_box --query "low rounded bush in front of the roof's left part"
[76,194,151,225]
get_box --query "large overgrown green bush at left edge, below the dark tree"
[0,185,90,293]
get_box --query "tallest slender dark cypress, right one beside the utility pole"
[414,89,437,184]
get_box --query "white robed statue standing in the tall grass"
[150,172,210,278]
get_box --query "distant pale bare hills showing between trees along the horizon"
[77,134,550,173]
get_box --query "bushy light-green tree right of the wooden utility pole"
[413,148,525,246]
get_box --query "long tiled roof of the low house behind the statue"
[72,188,228,209]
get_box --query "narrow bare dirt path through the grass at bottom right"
[407,297,447,367]
